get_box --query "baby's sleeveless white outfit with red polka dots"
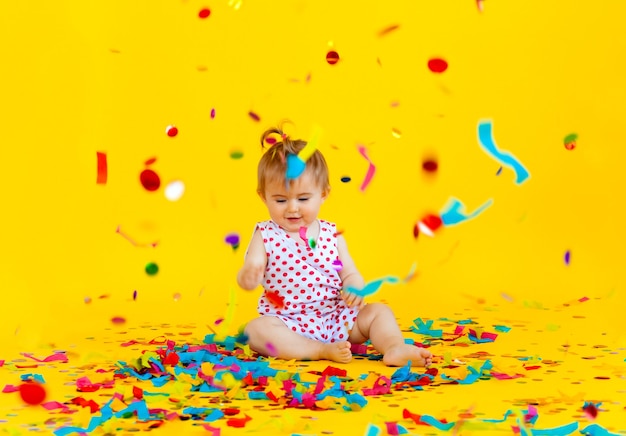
[257,220,358,342]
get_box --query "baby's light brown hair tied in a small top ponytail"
[257,125,330,196]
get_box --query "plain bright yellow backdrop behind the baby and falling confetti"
[0,0,626,430]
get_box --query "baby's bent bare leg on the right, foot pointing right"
[348,303,432,366]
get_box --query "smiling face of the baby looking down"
[262,171,327,233]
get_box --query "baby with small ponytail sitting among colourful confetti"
[237,128,432,366]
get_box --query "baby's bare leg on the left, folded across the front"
[245,316,352,363]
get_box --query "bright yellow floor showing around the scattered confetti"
[0,296,626,435]
